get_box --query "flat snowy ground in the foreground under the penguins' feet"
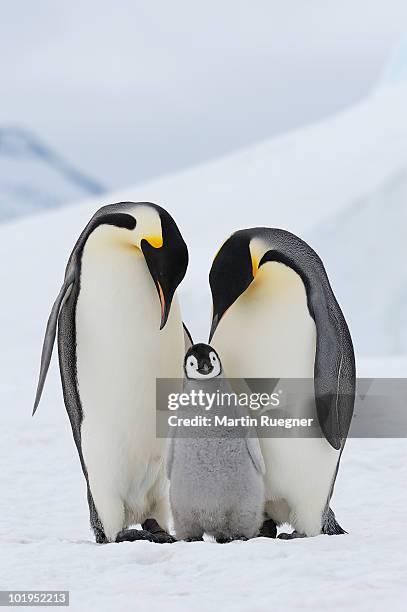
[0,344,407,612]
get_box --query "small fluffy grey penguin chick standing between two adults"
[167,344,265,543]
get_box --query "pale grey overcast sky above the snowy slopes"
[0,0,407,187]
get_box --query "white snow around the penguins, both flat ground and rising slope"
[0,68,407,612]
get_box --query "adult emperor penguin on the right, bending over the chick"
[209,228,355,539]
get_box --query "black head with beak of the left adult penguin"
[140,205,188,329]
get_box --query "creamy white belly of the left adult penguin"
[76,241,184,532]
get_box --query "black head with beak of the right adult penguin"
[209,230,256,342]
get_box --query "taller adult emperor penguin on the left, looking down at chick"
[33,202,188,543]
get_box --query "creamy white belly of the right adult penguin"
[213,262,339,535]
